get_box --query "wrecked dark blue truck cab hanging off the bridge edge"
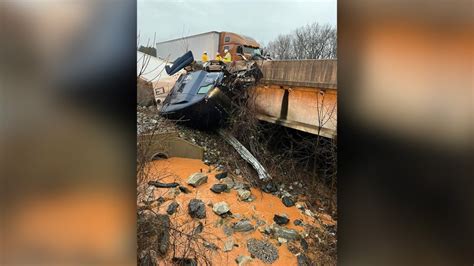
[160,51,262,128]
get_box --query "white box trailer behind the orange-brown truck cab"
[156,31,220,62]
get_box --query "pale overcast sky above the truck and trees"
[137,0,337,45]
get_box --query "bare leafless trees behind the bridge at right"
[264,22,337,59]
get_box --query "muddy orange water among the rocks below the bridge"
[144,158,317,265]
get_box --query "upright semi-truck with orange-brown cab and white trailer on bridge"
[156,31,262,62]
